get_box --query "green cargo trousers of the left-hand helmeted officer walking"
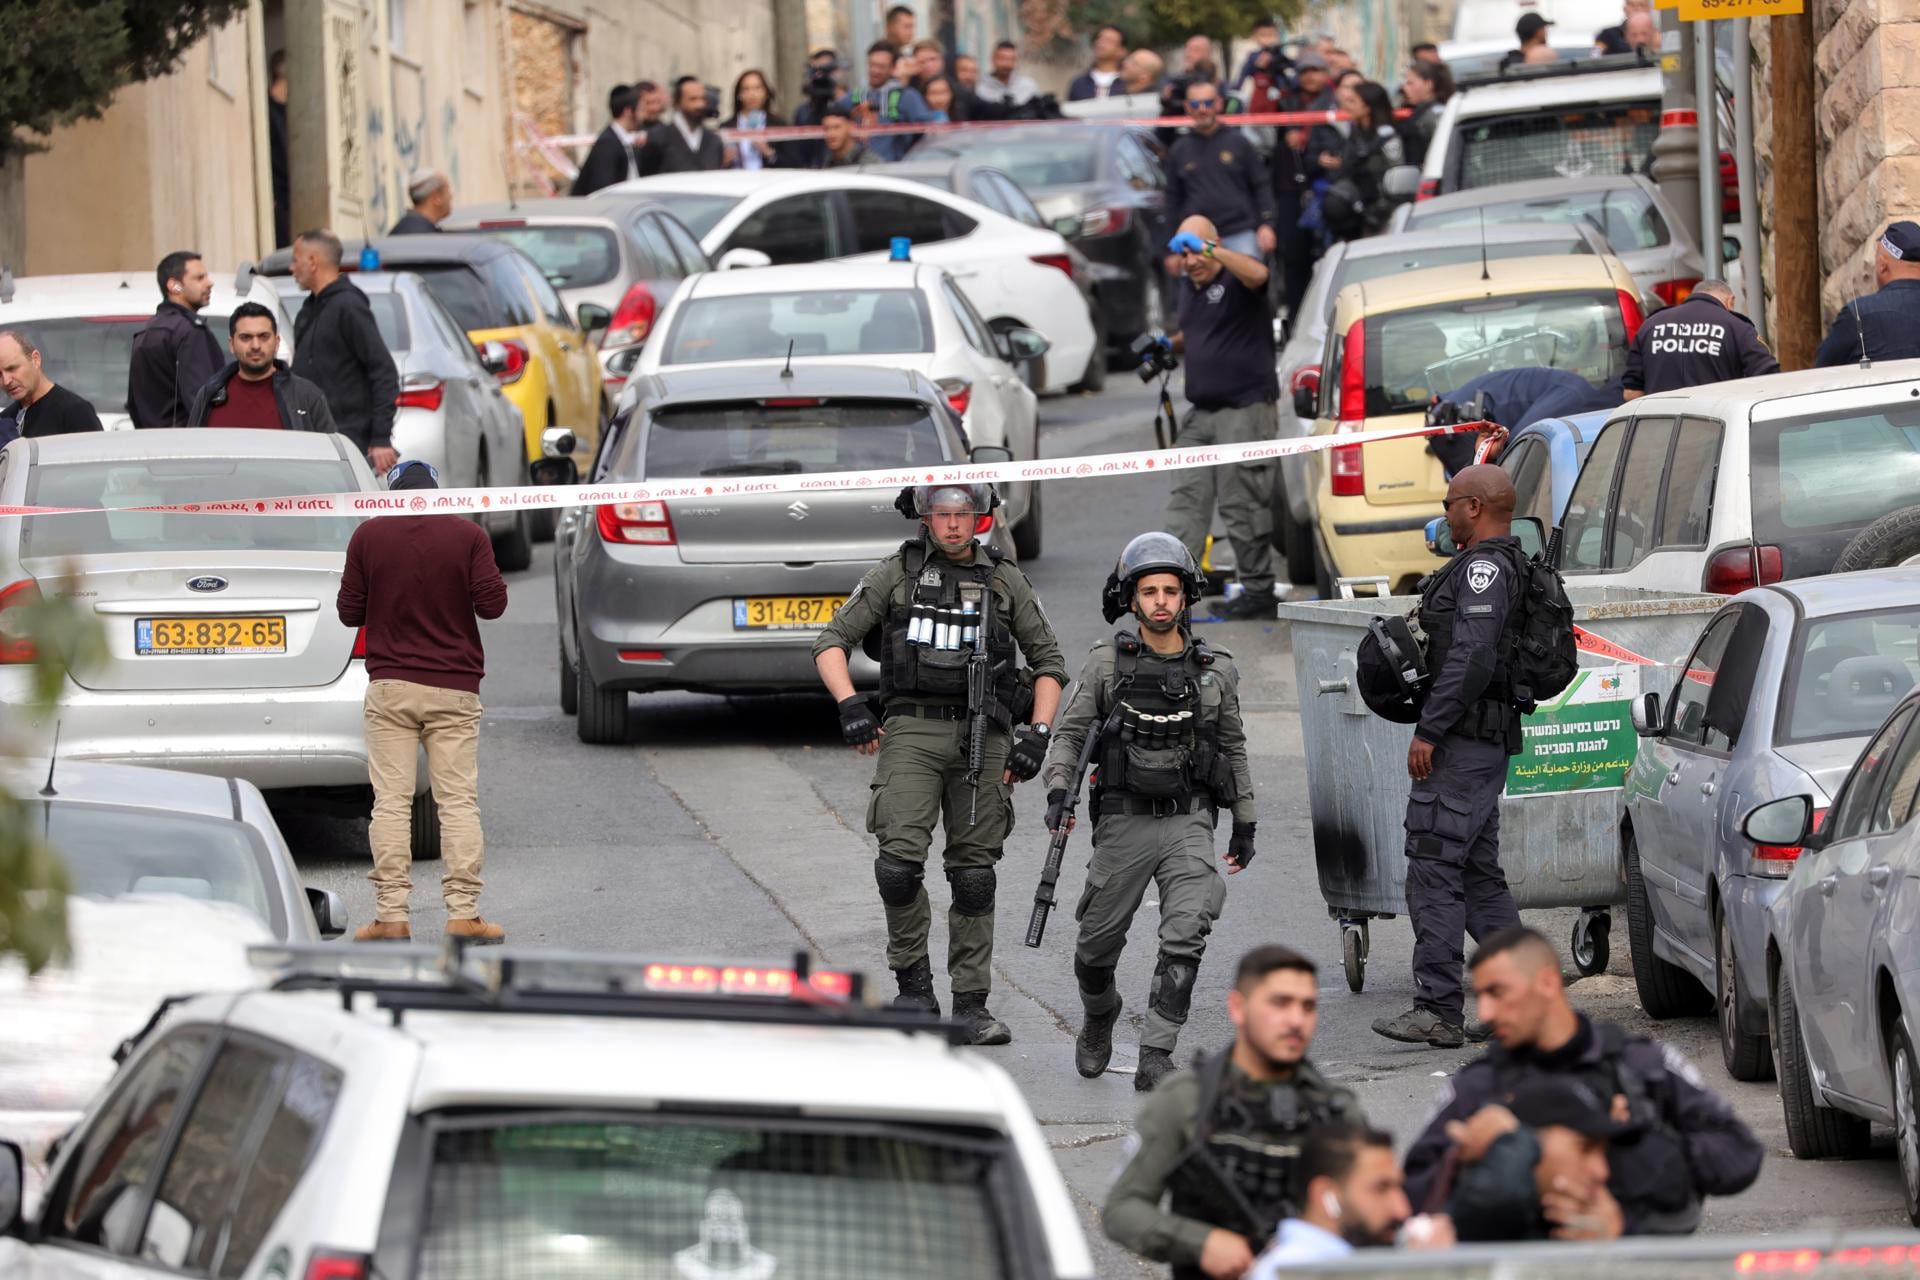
[866,716,1014,992]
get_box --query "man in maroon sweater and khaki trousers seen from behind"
[338,461,507,944]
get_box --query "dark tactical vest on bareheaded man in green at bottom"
[1167,1052,1348,1280]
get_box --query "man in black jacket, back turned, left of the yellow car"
[294,230,399,476]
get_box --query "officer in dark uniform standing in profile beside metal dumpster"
[1373,464,1526,1050]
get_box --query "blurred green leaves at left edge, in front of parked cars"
[0,599,104,973]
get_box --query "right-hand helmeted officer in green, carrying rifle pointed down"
[1046,533,1254,1092]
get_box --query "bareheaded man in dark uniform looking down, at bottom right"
[1405,925,1764,1236]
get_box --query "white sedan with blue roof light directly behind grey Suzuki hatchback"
[620,263,1046,560]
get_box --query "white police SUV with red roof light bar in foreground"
[0,946,1094,1280]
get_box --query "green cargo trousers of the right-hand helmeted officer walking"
[1073,810,1227,1052]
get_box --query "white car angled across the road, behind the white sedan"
[612,169,1106,393]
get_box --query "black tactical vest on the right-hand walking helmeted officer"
[1096,631,1238,812]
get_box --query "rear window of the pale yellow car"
[1334,292,1626,418]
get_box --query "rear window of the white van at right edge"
[1747,404,1920,578]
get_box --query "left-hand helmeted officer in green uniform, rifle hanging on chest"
[814,484,1066,1044]
